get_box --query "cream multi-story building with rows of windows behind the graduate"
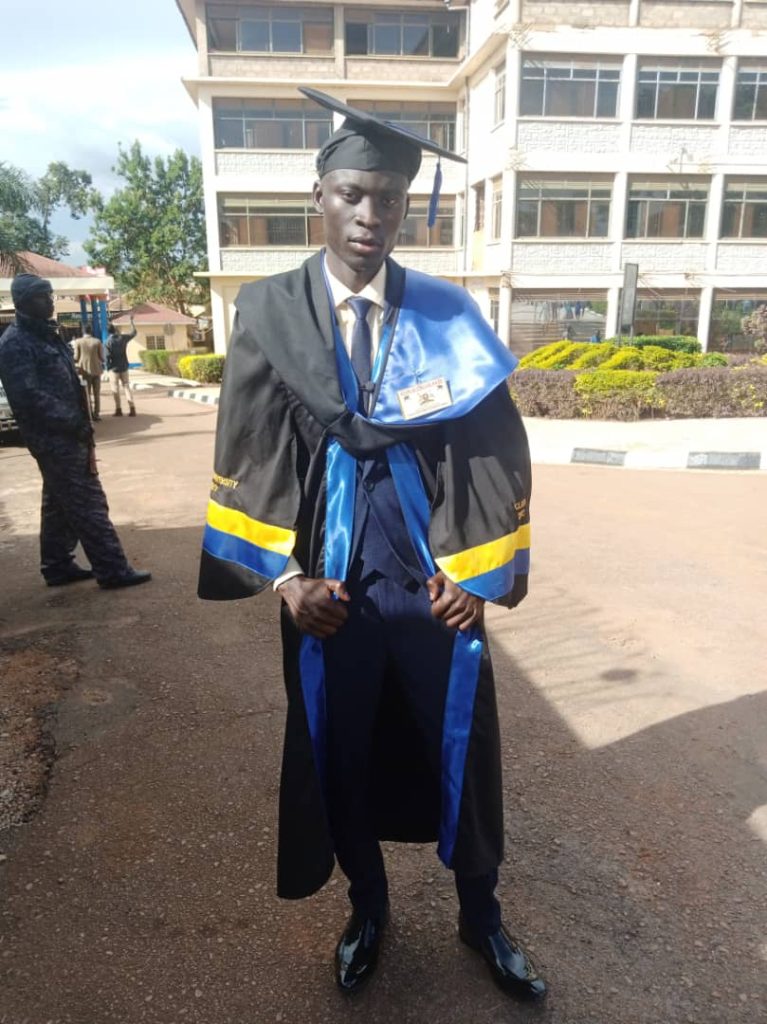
[176,0,767,353]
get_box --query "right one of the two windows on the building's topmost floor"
[346,9,461,58]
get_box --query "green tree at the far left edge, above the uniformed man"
[0,155,97,273]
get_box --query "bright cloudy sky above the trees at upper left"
[0,0,200,264]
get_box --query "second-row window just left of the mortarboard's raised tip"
[213,99,333,150]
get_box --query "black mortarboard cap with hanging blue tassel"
[299,86,466,222]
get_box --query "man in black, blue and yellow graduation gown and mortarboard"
[199,90,546,998]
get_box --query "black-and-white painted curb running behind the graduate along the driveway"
[168,388,767,471]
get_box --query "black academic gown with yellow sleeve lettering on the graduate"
[199,256,530,898]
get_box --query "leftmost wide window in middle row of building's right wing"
[516,180,611,239]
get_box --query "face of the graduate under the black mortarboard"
[312,170,409,290]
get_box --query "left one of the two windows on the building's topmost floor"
[208,4,333,53]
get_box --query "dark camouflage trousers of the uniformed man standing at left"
[35,441,129,582]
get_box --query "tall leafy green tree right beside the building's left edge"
[84,142,207,312]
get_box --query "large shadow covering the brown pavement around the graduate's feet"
[0,527,767,1024]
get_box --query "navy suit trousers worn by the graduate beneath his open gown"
[324,573,501,934]
